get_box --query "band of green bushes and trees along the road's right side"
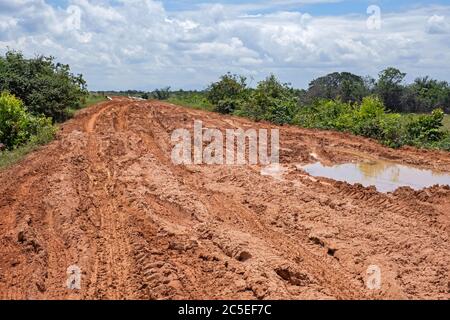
[149,68,450,151]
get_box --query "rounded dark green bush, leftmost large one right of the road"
[206,73,247,114]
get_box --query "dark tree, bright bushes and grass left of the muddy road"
[0,51,89,168]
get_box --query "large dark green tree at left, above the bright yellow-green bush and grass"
[0,51,87,121]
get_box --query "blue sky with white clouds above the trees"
[0,0,450,90]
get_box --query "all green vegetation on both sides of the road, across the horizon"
[0,51,450,168]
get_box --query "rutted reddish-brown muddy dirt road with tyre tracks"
[0,98,450,299]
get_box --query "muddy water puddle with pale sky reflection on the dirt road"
[298,161,450,192]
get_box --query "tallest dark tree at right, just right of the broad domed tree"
[376,68,406,111]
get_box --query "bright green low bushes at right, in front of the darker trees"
[293,96,450,150]
